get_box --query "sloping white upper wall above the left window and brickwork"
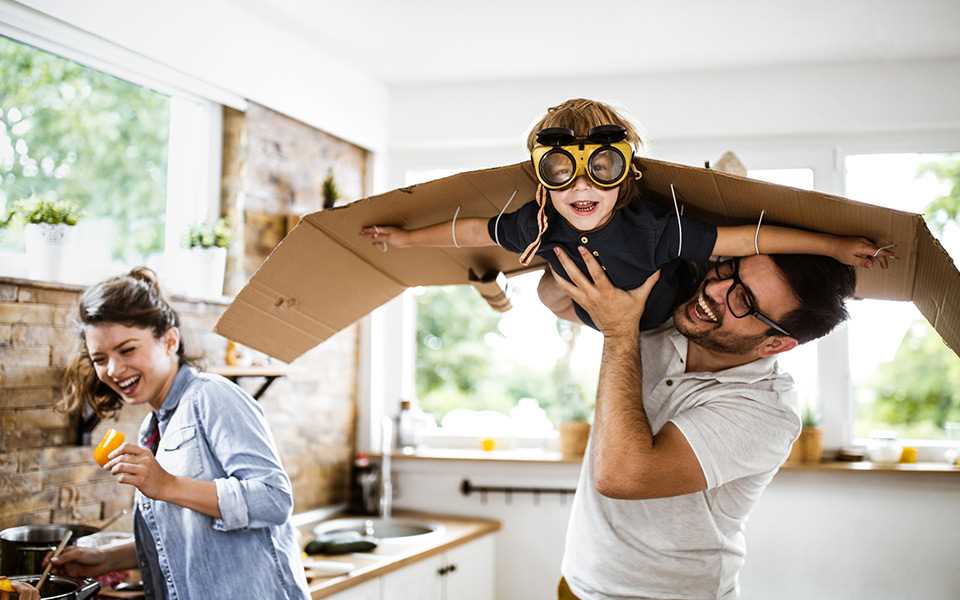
[2,0,388,152]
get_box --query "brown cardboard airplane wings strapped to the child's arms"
[216,158,960,361]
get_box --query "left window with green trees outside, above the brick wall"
[0,37,220,284]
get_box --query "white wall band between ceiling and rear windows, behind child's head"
[390,60,960,185]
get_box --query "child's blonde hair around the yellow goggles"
[520,98,643,265]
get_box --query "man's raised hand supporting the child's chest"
[553,246,660,337]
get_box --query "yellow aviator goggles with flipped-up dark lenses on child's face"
[530,125,633,190]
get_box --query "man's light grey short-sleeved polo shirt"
[562,324,800,600]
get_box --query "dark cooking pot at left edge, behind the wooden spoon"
[0,524,99,577]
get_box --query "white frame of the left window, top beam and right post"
[0,0,246,290]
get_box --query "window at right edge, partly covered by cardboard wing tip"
[845,154,960,440]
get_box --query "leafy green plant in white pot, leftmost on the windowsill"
[0,196,80,281]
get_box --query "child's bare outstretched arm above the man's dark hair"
[713,225,896,269]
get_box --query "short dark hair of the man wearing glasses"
[768,254,857,344]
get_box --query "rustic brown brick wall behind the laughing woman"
[0,104,366,529]
